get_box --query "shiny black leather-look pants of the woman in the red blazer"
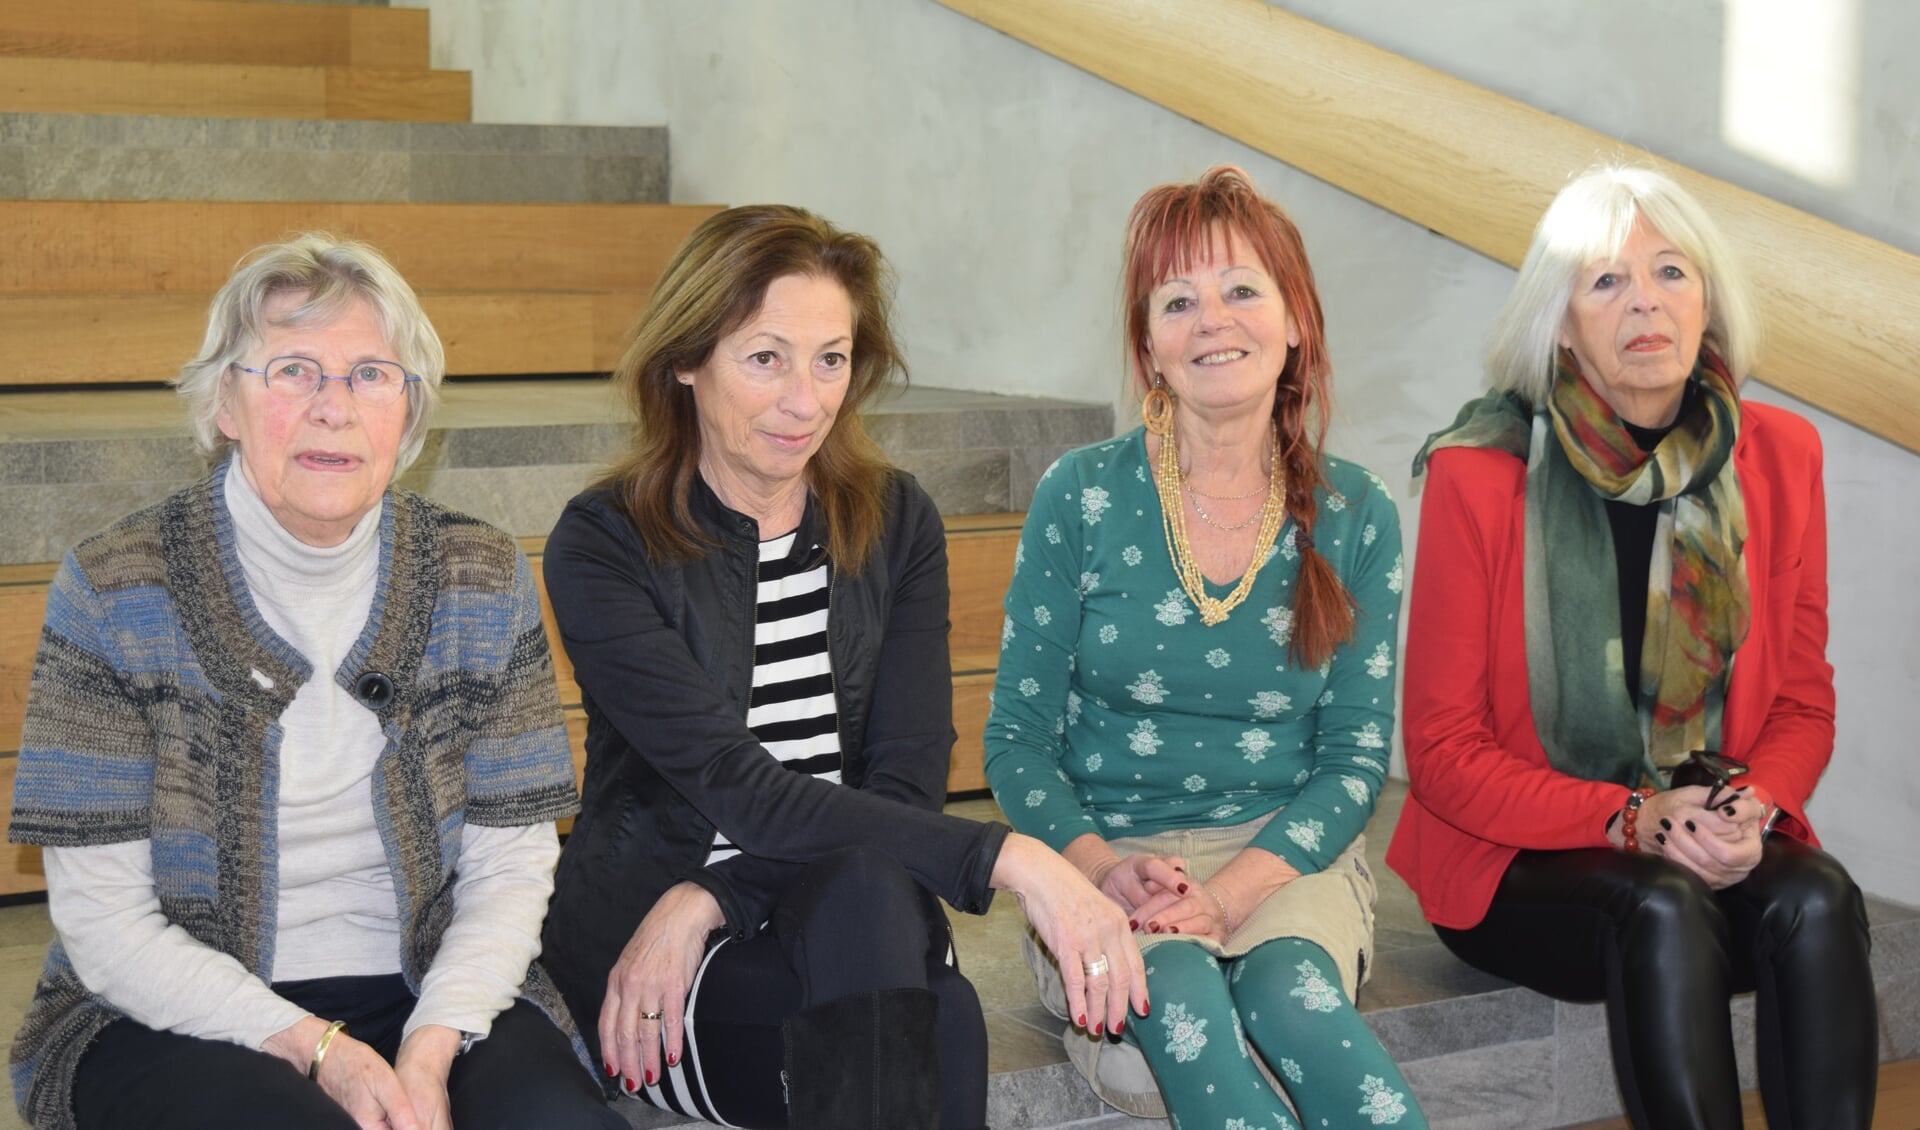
[1436,838,1880,1130]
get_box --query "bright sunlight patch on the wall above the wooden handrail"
[1720,0,1860,188]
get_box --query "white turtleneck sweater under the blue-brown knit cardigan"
[46,459,559,1048]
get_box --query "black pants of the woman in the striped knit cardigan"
[73,975,626,1130]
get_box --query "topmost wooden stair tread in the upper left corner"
[0,0,428,71]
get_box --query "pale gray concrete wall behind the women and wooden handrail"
[399,0,1920,902]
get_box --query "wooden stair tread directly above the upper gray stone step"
[0,56,472,121]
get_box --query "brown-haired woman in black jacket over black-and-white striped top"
[543,205,1146,1126]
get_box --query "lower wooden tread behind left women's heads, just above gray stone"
[0,288,647,386]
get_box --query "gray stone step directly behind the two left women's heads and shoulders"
[0,378,1114,564]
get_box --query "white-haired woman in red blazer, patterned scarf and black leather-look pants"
[1386,167,1878,1128]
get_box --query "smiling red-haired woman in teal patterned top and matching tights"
[987,167,1425,1130]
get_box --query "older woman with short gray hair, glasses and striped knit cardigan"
[12,234,624,1130]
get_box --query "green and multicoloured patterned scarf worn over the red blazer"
[1413,349,1749,785]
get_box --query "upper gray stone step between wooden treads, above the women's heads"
[0,113,668,203]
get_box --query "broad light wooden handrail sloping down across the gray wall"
[939,0,1920,451]
